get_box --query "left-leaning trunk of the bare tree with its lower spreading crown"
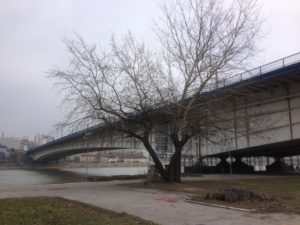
[50,33,169,177]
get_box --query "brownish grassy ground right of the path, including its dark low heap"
[129,175,300,214]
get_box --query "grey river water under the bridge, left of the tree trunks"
[0,167,147,187]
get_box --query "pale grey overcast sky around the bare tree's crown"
[0,0,300,139]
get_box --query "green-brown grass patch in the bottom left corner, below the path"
[0,197,155,225]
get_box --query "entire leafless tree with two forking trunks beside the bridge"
[50,0,261,182]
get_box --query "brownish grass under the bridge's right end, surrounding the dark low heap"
[131,176,300,214]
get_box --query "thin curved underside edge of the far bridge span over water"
[29,147,126,163]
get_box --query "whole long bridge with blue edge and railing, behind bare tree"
[27,53,300,172]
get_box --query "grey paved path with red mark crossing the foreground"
[0,178,300,225]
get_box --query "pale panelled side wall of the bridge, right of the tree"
[196,83,300,156]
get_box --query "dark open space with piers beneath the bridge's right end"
[200,138,300,173]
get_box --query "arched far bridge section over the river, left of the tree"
[27,124,140,162]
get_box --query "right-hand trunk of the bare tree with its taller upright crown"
[150,0,261,182]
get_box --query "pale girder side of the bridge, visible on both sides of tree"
[26,58,300,167]
